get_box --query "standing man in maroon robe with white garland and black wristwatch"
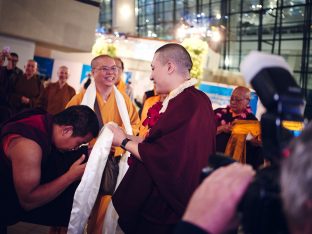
[109,44,216,234]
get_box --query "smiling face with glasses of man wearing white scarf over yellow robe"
[92,56,118,87]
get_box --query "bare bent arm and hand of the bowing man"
[7,137,85,210]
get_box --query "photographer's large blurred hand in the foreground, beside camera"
[183,163,255,233]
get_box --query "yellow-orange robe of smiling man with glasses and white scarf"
[66,90,140,234]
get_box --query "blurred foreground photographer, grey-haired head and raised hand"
[175,120,312,234]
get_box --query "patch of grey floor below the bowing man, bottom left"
[8,222,50,234]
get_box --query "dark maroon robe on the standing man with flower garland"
[113,87,216,233]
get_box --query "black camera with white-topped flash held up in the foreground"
[205,52,305,234]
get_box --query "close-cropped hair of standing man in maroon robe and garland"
[155,43,193,72]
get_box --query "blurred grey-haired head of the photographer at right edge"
[281,120,312,234]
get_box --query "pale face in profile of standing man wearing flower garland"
[150,53,170,94]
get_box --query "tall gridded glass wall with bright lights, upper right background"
[136,0,312,116]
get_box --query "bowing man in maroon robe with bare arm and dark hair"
[0,106,99,227]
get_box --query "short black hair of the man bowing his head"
[53,105,99,137]
